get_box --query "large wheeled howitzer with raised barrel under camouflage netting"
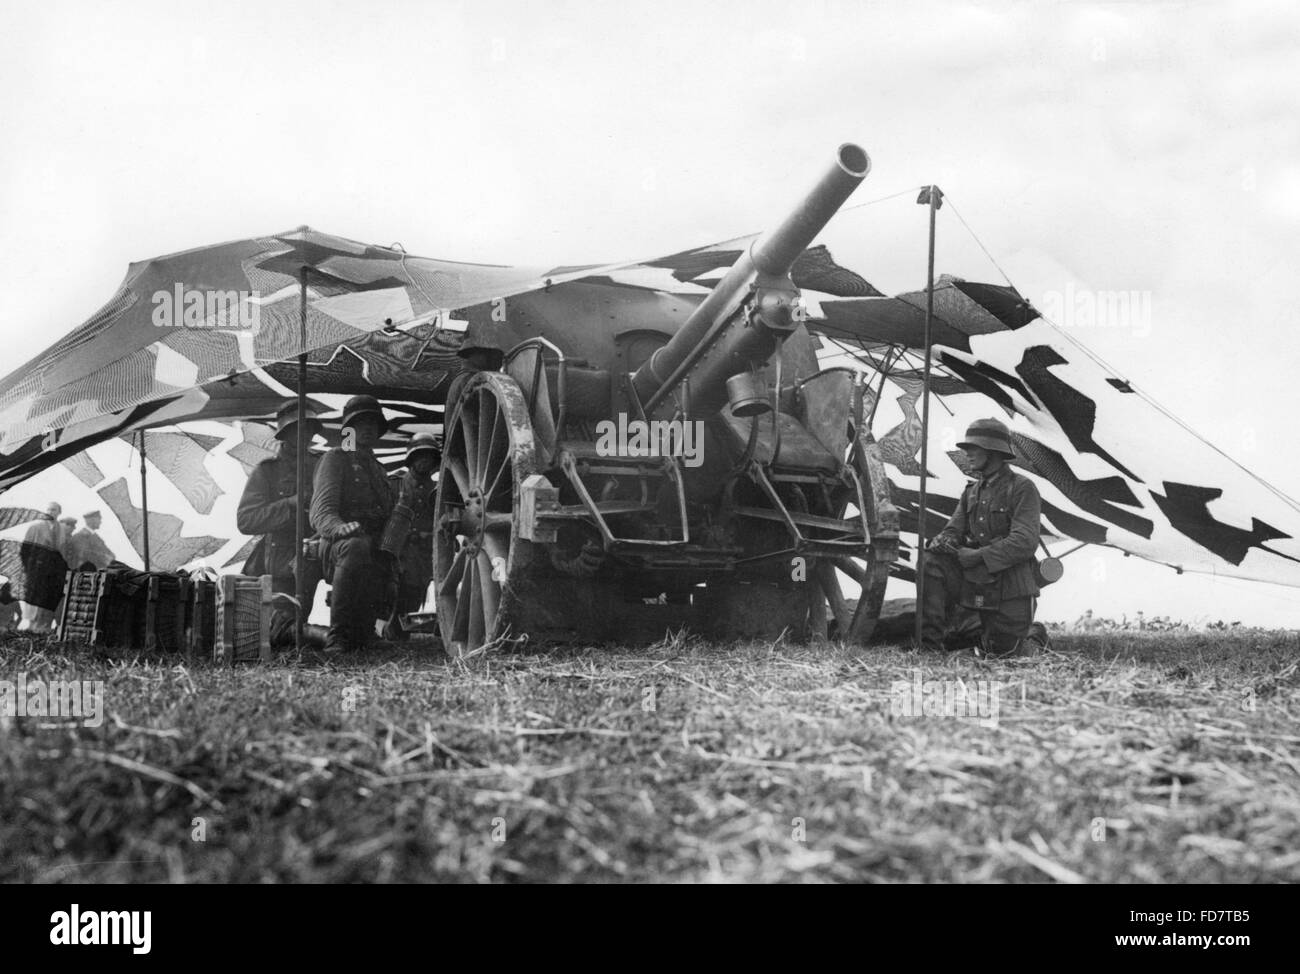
[434,144,898,654]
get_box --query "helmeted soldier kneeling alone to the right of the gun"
[920,419,1048,657]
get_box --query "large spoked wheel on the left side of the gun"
[433,372,536,657]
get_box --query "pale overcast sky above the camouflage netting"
[0,0,1300,625]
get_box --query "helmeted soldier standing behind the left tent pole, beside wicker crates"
[235,399,321,646]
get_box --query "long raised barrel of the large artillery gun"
[632,142,871,419]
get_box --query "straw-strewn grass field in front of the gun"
[0,631,1300,883]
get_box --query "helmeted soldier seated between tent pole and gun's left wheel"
[311,395,393,654]
